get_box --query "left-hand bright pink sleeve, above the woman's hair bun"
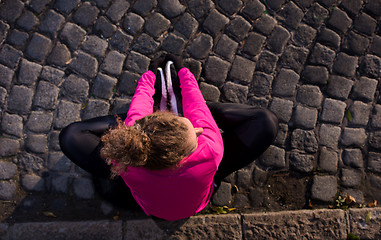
[125,71,156,126]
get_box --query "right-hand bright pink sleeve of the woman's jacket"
[178,68,223,164]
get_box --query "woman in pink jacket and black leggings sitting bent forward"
[60,54,278,220]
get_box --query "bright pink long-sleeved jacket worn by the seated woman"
[121,68,224,221]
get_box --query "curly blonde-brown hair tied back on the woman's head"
[100,112,190,177]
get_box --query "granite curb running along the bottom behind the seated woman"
[0,208,381,240]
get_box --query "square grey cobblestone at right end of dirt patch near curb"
[311,176,337,202]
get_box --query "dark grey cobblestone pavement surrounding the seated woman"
[0,0,381,221]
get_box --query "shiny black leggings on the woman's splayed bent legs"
[59,102,278,204]
